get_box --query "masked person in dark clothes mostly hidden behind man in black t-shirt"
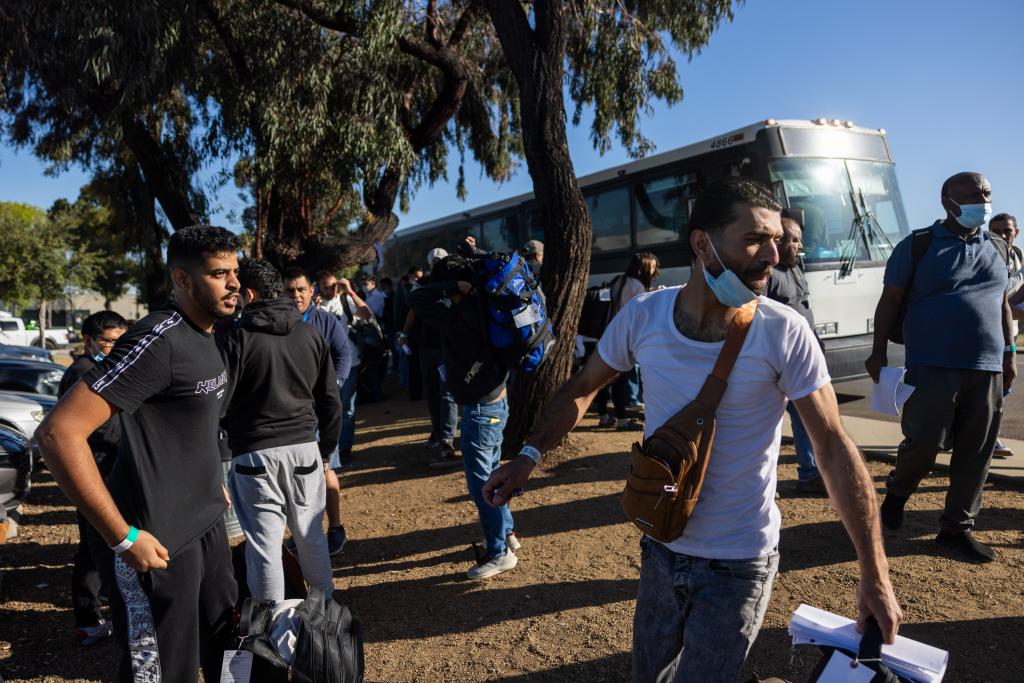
[57,310,128,645]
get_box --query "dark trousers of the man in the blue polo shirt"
[887,367,1002,531]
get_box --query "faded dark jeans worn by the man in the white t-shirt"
[633,537,778,683]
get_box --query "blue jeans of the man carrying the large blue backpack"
[460,397,513,558]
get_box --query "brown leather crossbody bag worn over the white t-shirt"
[623,299,758,543]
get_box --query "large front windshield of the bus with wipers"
[771,159,907,264]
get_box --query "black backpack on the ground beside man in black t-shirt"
[239,588,364,683]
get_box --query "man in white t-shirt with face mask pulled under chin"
[483,179,902,683]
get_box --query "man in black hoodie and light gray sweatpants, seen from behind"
[223,259,341,600]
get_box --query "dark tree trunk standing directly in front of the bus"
[484,0,592,451]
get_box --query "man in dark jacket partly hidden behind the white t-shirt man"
[767,209,827,495]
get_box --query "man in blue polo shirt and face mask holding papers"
[864,173,1017,562]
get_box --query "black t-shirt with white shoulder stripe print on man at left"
[82,307,227,556]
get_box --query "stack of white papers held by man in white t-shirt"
[790,605,949,683]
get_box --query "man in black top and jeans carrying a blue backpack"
[409,256,518,579]
